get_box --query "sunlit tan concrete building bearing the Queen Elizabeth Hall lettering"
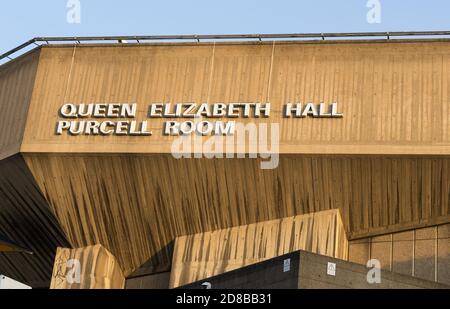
[0,33,450,288]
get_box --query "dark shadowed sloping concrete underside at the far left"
[0,155,71,288]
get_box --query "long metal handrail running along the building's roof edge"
[0,31,450,60]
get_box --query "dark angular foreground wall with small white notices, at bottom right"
[181,251,450,289]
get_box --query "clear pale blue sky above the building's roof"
[0,0,450,53]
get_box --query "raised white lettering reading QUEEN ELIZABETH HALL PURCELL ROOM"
[56,103,343,136]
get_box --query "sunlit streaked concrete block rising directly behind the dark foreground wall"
[170,209,348,288]
